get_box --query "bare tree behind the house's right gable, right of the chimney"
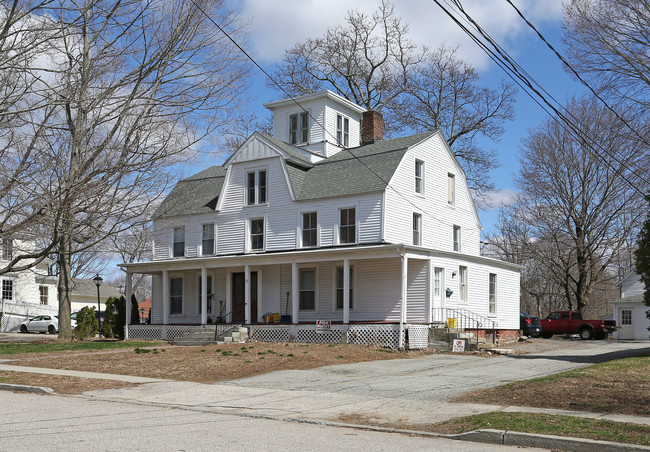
[395,45,516,200]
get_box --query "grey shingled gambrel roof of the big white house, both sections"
[154,132,435,219]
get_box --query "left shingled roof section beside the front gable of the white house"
[153,166,226,219]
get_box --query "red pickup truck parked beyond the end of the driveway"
[539,311,616,340]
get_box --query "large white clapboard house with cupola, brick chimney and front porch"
[122,91,520,345]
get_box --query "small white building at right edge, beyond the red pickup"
[610,272,650,341]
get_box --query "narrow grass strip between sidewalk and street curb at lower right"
[427,412,650,446]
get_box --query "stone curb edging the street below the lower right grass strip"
[443,429,650,452]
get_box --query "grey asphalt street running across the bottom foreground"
[0,391,543,452]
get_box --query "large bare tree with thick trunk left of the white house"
[0,0,248,340]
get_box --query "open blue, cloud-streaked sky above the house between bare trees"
[209,0,583,237]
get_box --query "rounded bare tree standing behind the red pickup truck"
[513,98,648,311]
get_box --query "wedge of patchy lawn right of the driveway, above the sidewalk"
[451,357,650,416]
